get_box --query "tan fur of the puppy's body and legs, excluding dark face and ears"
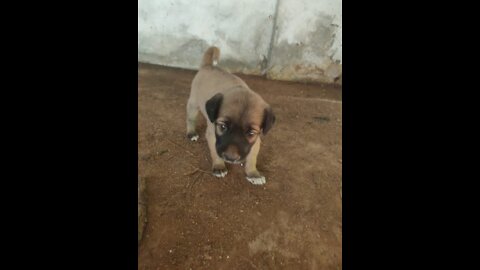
[187,47,269,185]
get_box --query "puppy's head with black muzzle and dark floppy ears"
[205,91,275,163]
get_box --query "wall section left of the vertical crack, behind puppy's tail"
[138,0,276,74]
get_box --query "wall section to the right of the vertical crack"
[267,0,342,82]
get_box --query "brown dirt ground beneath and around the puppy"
[138,64,342,269]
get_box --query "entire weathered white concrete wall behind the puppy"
[138,0,342,82]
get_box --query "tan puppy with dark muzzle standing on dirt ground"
[187,47,275,185]
